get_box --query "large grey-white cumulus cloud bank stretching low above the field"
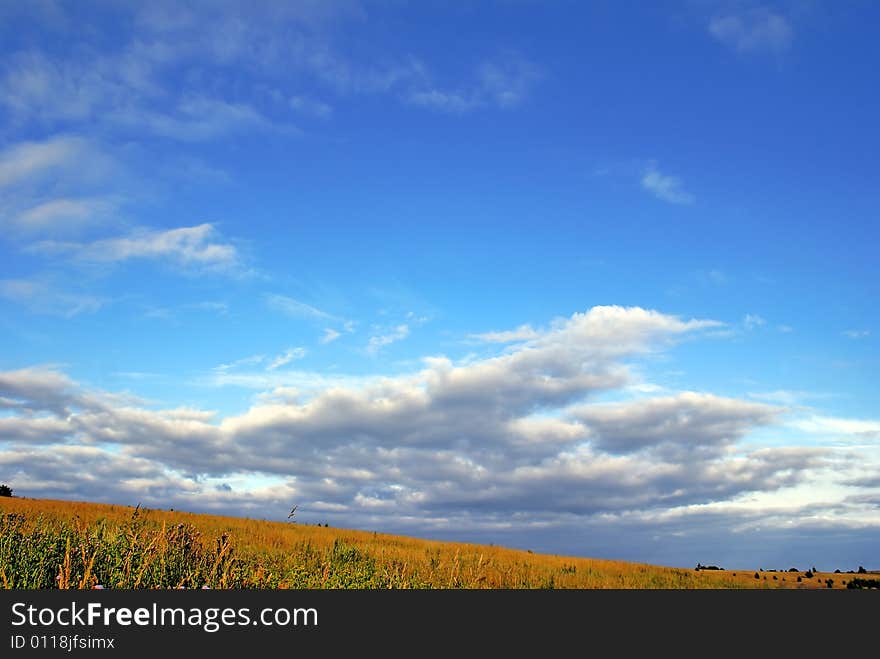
[0,307,876,564]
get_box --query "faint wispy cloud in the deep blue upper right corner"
[709,8,794,53]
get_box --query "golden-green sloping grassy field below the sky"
[0,497,880,589]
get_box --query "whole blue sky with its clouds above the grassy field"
[0,0,880,568]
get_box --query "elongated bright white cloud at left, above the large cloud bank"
[31,224,240,271]
